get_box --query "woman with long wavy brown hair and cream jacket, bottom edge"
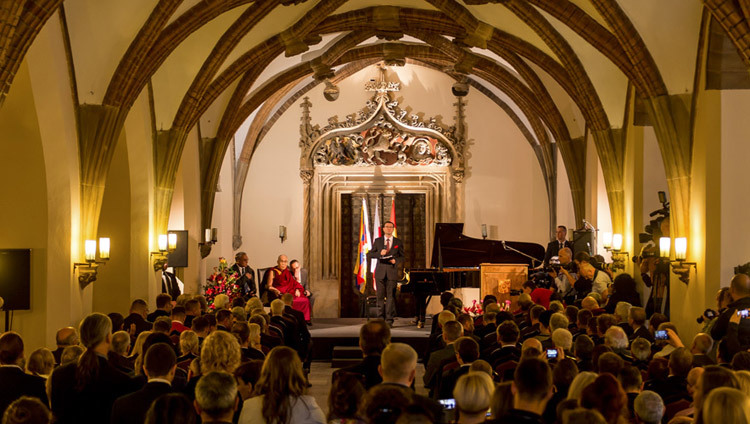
[239,346,326,424]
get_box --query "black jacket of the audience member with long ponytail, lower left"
[50,356,140,424]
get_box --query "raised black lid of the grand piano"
[432,223,544,268]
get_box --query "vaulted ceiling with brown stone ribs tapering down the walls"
[0,0,750,243]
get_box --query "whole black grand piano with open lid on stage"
[401,223,544,314]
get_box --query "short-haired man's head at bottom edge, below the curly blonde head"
[193,371,238,423]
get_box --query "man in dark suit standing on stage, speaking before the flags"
[367,221,404,326]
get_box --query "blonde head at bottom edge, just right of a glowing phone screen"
[453,371,495,424]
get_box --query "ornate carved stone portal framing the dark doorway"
[299,67,466,317]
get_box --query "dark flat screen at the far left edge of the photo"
[0,249,31,310]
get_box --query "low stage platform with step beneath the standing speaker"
[310,318,432,361]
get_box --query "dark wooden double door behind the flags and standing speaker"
[339,193,427,318]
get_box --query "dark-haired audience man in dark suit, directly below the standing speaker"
[331,319,391,390]
